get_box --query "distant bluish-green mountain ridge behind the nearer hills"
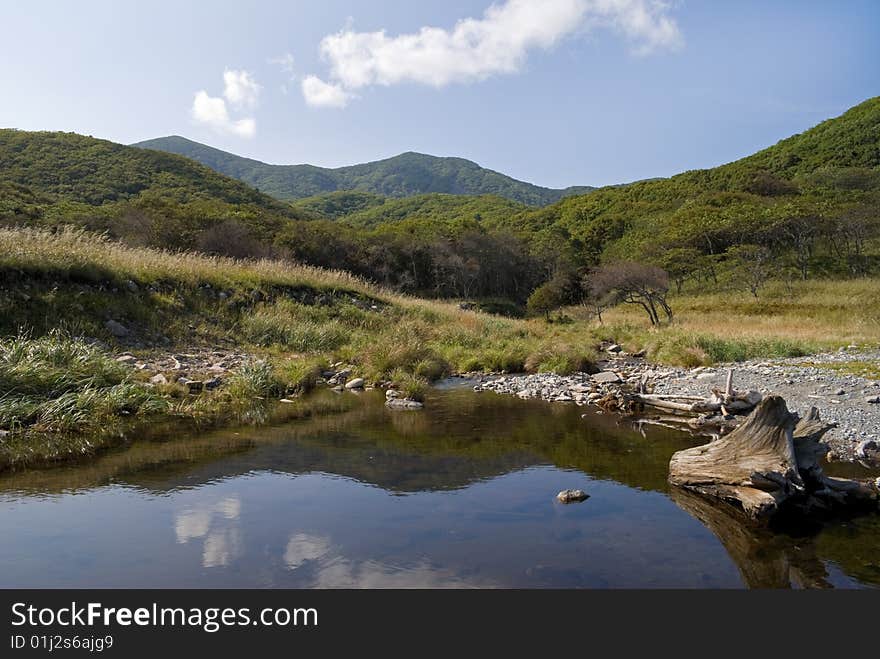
[133,136,592,206]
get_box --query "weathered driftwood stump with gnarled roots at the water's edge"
[669,396,876,519]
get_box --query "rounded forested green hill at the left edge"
[0,130,313,248]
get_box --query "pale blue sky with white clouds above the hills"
[0,0,880,187]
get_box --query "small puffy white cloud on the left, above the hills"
[191,69,260,137]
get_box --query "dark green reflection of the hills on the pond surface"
[0,391,693,494]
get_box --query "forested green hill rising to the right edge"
[507,97,880,273]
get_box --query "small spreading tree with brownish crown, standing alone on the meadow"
[590,261,673,325]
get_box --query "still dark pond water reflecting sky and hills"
[0,388,880,588]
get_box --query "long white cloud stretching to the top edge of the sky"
[302,0,682,107]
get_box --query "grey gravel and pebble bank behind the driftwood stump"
[474,349,880,461]
